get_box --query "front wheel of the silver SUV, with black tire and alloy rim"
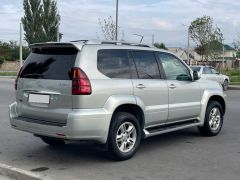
[199,101,223,136]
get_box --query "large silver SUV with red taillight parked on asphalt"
[9,40,226,160]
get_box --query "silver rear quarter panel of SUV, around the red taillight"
[72,45,133,109]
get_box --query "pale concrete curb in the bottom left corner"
[0,164,47,180]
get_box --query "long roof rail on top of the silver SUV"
[70,40,150,47]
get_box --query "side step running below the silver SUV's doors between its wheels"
[143,119,201,138]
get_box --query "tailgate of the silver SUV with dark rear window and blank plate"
[16,47,78,125]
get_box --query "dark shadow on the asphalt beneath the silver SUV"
[15,128,201,169]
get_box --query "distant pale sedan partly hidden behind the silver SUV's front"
[191,66,230,91]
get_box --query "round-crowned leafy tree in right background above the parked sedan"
[189,16,223,61]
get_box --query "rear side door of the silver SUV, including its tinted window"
[130,51,168,126]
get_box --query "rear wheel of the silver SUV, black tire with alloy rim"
[108,112,141,161]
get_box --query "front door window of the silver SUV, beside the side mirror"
[158,53,192,81]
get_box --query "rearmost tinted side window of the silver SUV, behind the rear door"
[97,49,131,79]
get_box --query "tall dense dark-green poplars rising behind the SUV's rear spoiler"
[22,0,60,44]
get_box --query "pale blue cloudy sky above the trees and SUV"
[0,0,240,47]
